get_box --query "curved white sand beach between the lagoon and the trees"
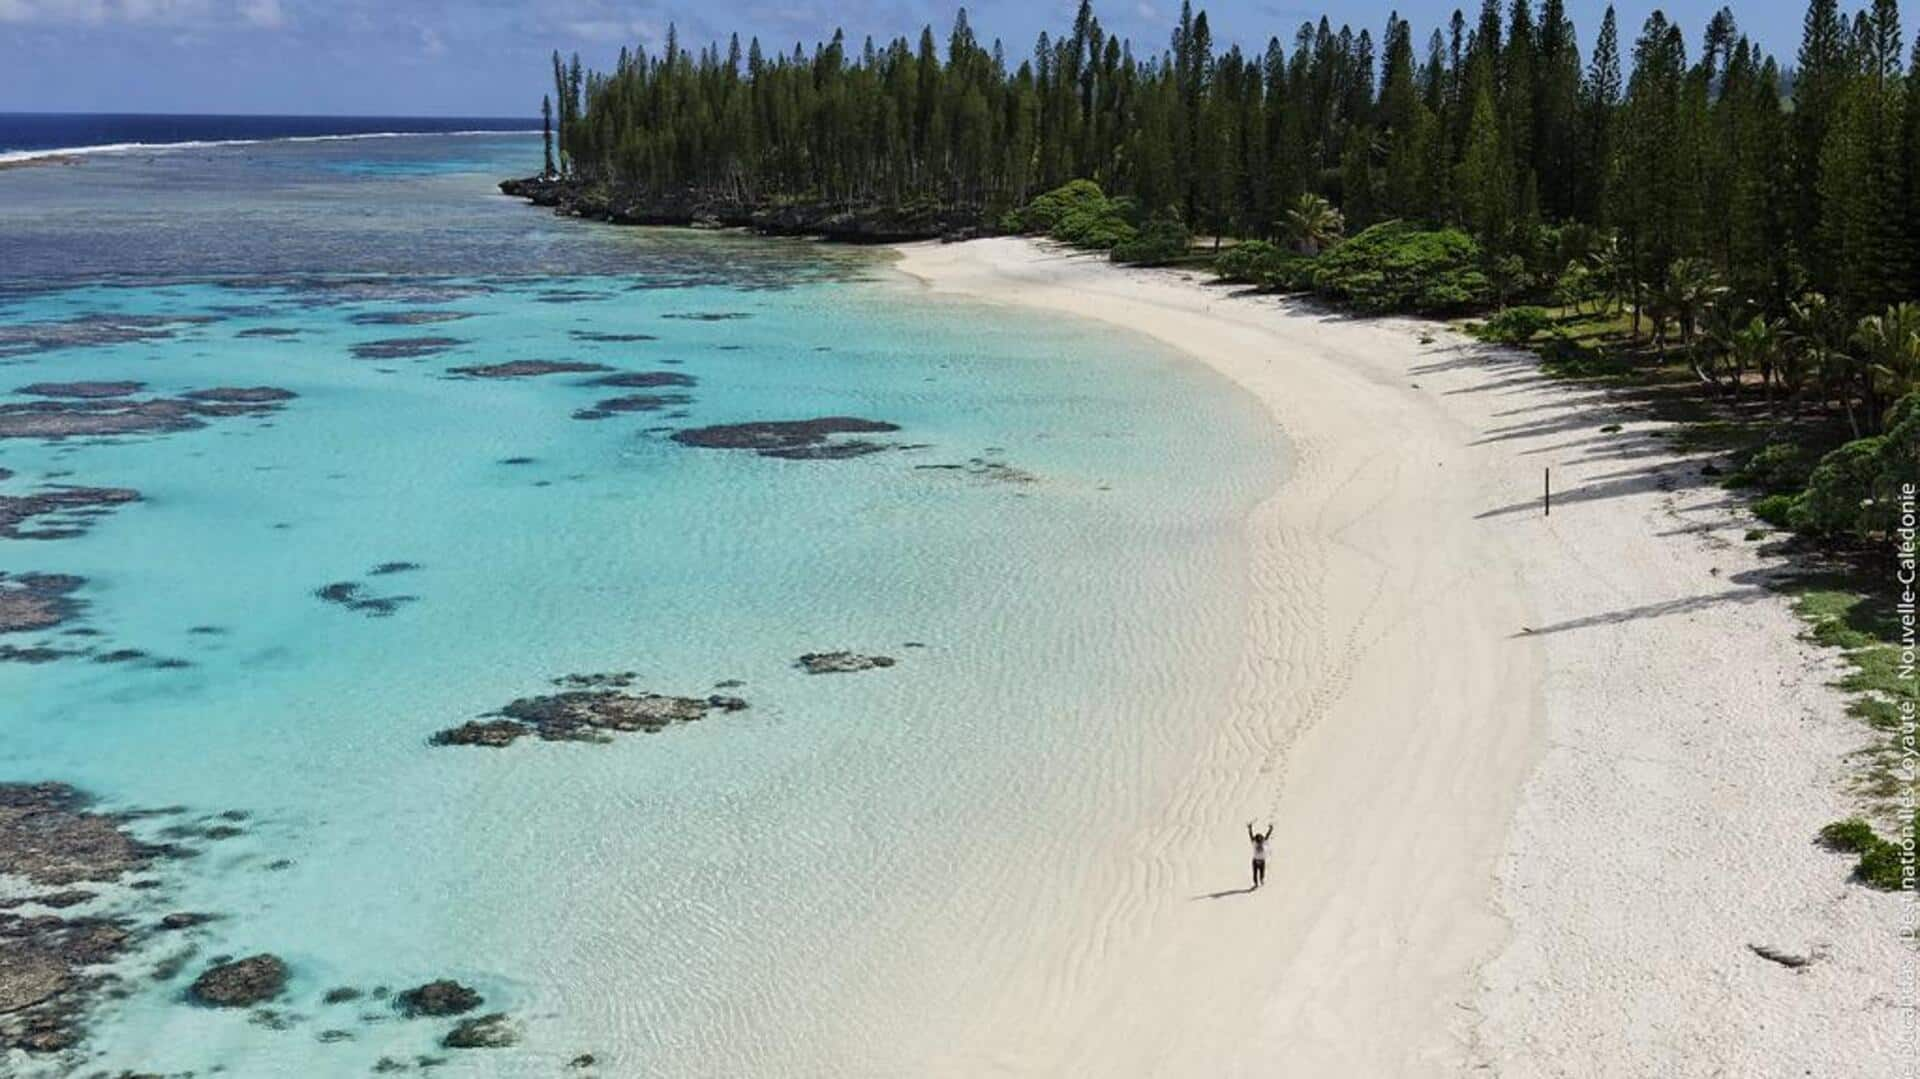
[899,240,1914,1077]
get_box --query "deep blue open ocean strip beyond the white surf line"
[0,113,540,161]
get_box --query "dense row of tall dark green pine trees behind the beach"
[553,0,1920,313]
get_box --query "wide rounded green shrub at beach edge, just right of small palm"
[1313,221,1492,315]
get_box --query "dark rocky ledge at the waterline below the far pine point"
[499,177,989,244]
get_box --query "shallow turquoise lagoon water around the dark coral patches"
[0,138,1277,1075]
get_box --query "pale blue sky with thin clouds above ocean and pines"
[0,0,1820,115]
